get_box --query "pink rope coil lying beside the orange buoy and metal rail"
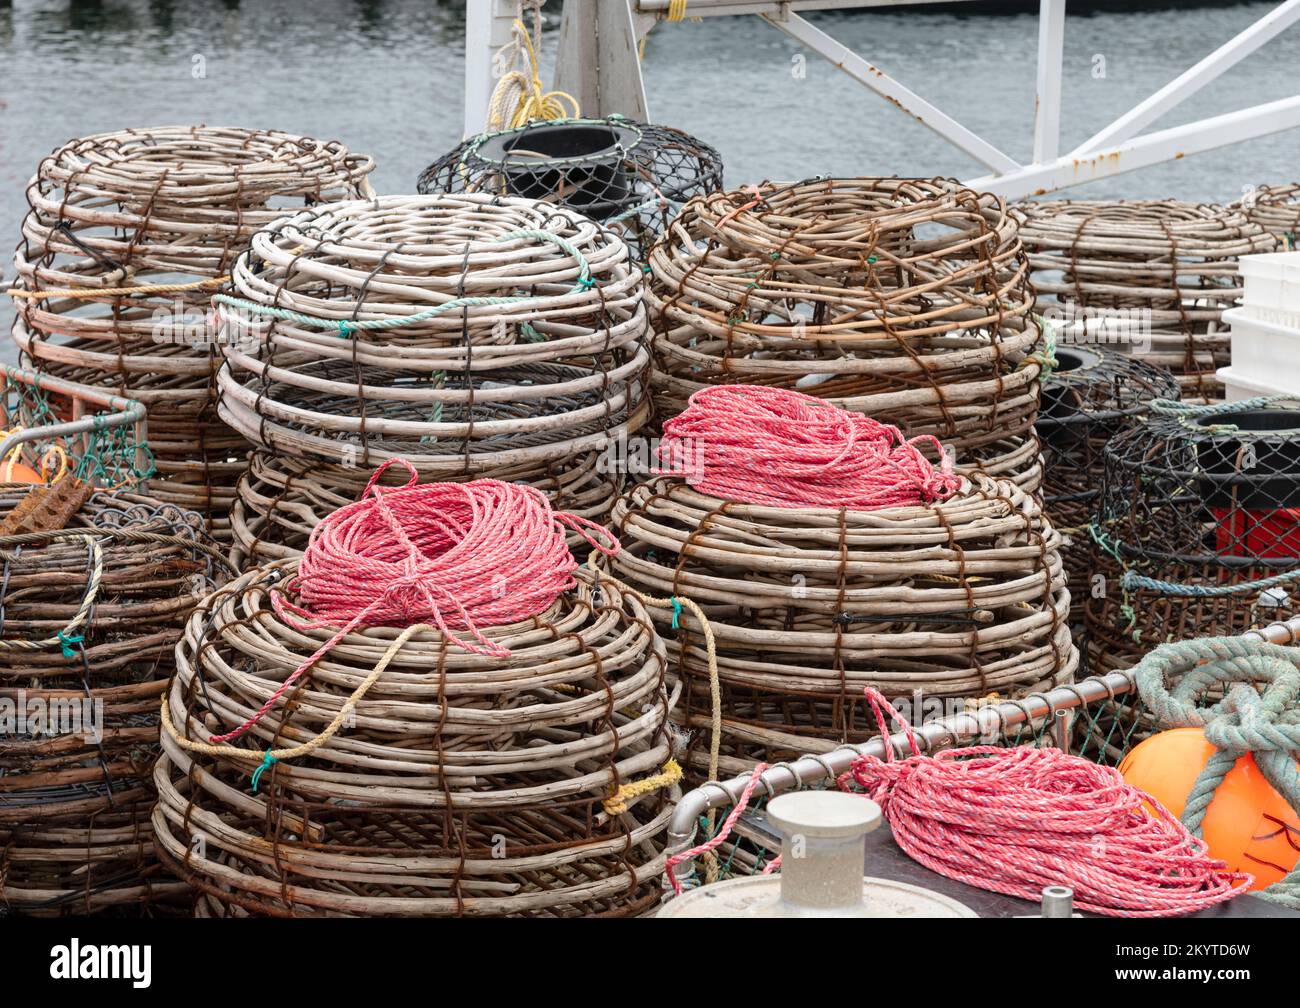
[840,688,1253,917]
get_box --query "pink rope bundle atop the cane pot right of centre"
[658,385,961,510]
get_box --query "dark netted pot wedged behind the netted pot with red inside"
[1035,346,1179,626]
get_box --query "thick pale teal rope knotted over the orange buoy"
[1132,637,1300,910]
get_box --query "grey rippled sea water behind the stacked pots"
[0,0,1300,345]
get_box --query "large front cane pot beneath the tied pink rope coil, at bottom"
[153,561,676,917]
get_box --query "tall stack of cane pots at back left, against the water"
[13,126,373,540]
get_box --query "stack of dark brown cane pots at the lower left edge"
[0,485,224,916]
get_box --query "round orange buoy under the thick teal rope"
[1119,728,1300,890]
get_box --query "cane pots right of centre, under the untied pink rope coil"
[608,477,1078,780]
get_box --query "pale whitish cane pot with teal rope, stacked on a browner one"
[215,194,650,566]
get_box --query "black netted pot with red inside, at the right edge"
[1086,399,1300,691]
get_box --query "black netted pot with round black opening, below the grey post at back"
[416,116,723,259]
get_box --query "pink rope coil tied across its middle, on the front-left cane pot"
[208,458,619,743]
